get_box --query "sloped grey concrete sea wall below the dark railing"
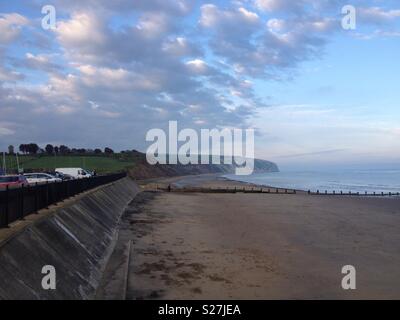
[0,178,139,299]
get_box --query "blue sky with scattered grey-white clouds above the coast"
[0,0,400,168]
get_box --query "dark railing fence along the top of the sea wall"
[0,173,126,228]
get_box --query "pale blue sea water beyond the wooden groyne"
[225,170,400,193]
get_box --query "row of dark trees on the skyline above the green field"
[8,143,114,155]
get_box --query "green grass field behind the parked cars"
[0,154,134,173]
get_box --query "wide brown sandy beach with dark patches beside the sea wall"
[98,176,400,299]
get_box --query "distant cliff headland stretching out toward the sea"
[128,153,279,180]
